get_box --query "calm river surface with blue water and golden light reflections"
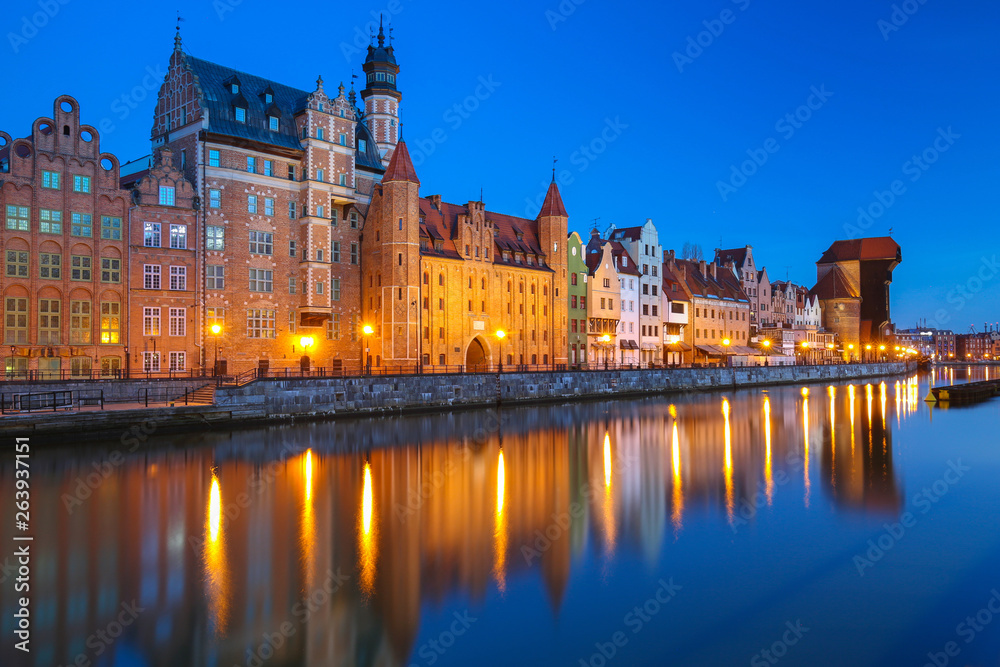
[0,367,1000,667]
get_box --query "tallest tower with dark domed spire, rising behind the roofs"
[361,19,403,165]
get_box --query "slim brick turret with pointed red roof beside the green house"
[538,177,569,364]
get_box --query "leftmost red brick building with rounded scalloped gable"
[0,95,130,378]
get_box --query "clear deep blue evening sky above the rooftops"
[0,0,1000,332]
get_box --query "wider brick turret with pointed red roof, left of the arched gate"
[362,141,420,366]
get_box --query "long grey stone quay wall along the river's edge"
[0,363,916,446]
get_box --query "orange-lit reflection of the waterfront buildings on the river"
[0,381,916,665]
